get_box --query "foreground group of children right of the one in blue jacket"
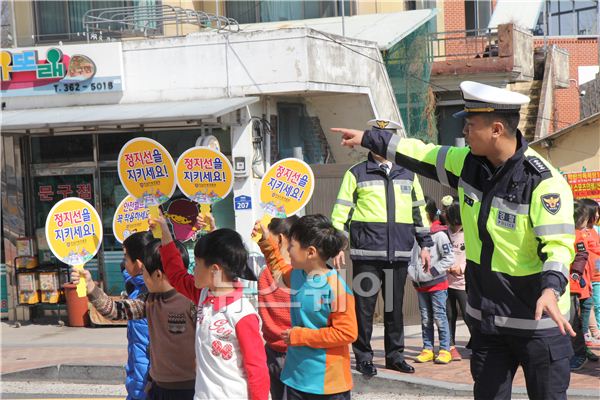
[71,211,357,400]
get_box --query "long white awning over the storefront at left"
[0,97,258,132]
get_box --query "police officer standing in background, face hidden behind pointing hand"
[331,120,433,376]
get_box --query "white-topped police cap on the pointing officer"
[453,81,529,118]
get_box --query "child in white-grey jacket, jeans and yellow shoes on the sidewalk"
[408,197,454,364]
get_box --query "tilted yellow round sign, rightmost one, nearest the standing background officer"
[260,158,315,218]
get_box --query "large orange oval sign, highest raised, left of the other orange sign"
[118,138,176,207]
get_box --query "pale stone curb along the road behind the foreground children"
[0,364,598,400]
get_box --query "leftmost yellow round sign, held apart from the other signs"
[46,197,102,265]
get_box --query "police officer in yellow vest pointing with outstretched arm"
[333,81,575,400]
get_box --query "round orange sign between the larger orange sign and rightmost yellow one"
[176,147,233,204]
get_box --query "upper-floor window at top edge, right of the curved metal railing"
[225,0,356,24]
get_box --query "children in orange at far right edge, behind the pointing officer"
[569,199,600,371]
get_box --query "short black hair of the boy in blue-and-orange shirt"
[290,214,348,261]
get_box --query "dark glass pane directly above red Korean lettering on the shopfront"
[31,135,94,164]
